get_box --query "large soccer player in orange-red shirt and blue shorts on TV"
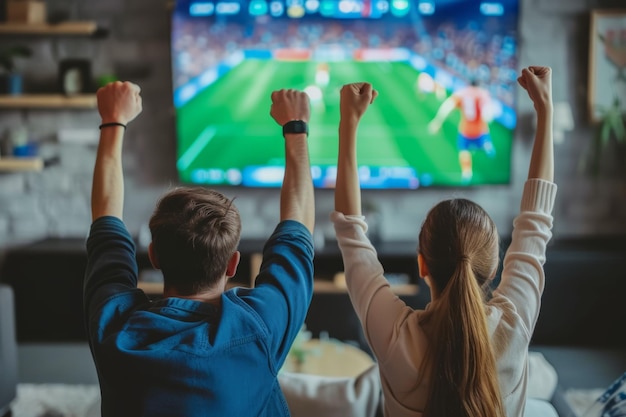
[428,82,496,182]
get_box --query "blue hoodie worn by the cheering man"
[84,217,313,417]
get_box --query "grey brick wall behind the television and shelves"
[0,0,626,249]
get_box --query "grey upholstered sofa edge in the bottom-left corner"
[0,284,17,416]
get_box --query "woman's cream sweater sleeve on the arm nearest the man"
[331,211,410,362]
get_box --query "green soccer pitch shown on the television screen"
[177,60,512,186]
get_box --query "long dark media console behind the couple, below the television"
[0,238,626,350]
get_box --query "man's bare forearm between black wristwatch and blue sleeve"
[280,134,315,233]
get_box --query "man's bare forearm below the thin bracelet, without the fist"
[91,126,124,220]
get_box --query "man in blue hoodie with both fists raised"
[84,82,315,417]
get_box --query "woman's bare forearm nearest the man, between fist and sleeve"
[335,120,361,215]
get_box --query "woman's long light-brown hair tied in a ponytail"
[418,199,504,417]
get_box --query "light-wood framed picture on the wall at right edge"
[588,9,626,122]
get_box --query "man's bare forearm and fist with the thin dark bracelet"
[91,81,142,220]
